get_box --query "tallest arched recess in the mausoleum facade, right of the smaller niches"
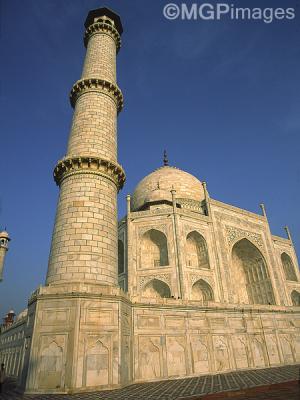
[231,239,275,304]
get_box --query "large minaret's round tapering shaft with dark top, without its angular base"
[46,8,125,286]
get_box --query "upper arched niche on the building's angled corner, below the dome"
[141,229,169,268]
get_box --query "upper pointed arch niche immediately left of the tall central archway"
[186,231,210,268]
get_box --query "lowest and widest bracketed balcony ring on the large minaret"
[53,156,126,191]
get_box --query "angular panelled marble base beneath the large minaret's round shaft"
[21,283,132,393]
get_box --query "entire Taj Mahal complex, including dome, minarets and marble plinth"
[0,8,300,393]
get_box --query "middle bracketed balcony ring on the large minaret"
[70,78,124,113]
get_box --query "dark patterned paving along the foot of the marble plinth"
[0,365,300,400]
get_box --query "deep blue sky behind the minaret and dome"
[0,0,300,316]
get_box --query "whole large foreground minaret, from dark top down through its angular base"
[22,8,131,393]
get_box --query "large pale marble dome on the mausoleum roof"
[131,165,204,211]
